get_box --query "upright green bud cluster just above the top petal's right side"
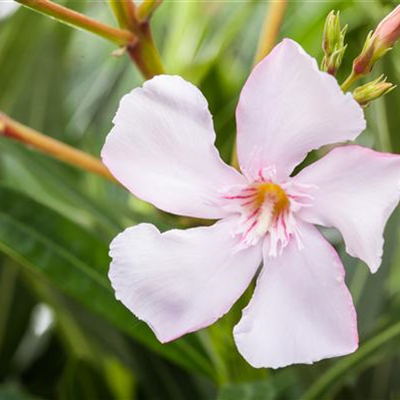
[321,11,347,75]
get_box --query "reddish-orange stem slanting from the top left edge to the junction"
[16,0,136,46]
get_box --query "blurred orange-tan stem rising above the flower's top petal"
[254,0,287,64]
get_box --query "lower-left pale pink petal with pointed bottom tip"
[109,219,261,342]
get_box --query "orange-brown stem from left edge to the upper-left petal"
[0,112,115,182]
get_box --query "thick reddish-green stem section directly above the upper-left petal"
[128,22,165,79]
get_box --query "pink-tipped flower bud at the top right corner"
[353,6,400,76]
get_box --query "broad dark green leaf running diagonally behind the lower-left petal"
[0,186,213,376]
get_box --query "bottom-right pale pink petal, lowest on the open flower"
[234,223,358,368]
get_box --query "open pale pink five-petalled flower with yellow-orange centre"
[102,39,400,368]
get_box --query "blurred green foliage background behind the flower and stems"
[0,0,400,400]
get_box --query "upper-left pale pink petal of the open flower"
[102,75,244,218]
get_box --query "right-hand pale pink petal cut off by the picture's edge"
[295,146,400,272]
